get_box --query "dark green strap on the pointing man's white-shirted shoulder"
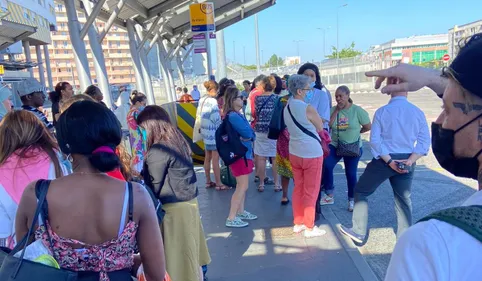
[418,205,482,242]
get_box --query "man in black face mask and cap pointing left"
[367,34,482,281]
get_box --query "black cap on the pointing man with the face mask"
[450,33,482,98]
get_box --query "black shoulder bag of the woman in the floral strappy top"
[0,180,78,281]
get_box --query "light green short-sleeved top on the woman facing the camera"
[330,104,370,147]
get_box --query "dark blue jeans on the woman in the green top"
[321,144,363,200]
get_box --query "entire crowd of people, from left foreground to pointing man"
[0,31,482,281]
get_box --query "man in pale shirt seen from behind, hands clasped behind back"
[341,89,430,243]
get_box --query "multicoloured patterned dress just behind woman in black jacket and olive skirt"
[127,107,146,172]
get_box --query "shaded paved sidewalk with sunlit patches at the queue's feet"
[197,170,377,281]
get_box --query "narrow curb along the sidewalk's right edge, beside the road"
[321,206,379,281]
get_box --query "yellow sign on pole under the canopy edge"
[189,2,216,32]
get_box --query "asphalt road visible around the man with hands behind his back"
[331,90,477,280]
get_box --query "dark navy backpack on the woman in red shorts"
[216,112,248,166]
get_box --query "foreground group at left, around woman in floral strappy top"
[0,78,211,281]
